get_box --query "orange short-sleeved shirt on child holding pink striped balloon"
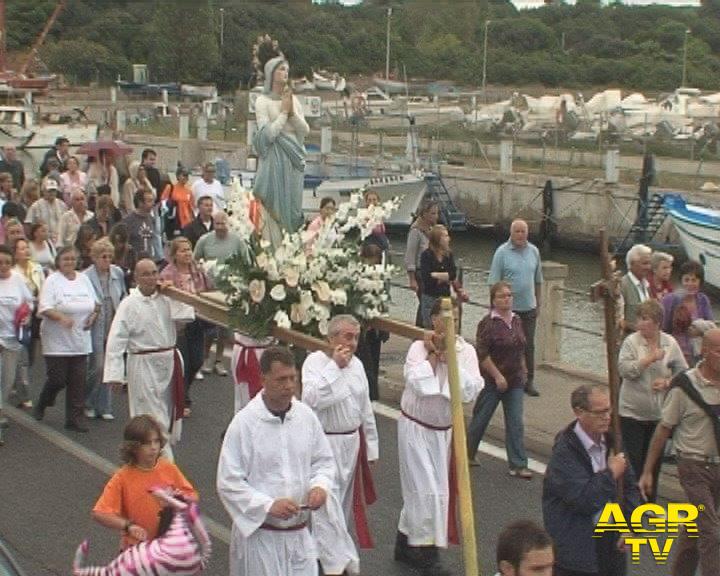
[93,458,197,548]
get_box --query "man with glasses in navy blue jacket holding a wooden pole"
[542,384,640,576]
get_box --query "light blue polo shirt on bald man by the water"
[488,240,543,312]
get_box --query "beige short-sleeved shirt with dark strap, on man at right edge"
[661,364,720,457]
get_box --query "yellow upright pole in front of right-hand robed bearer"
[442,298,480,576]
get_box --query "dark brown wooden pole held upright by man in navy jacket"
[600,228,623,501]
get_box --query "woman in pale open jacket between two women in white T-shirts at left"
[13,239,45,408]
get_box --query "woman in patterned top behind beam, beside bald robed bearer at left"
[160,237,211,417]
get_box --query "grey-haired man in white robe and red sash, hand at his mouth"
[302,314,379,575]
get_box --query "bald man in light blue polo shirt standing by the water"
[488,220,543,396]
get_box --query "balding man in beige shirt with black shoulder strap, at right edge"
[639,328,720,576]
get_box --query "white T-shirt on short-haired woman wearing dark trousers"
[38,272,99,356]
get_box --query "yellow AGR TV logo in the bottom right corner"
[593,502,705,565]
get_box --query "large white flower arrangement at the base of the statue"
[213,180,400,339]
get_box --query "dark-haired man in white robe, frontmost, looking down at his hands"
[217,346,335,576]
